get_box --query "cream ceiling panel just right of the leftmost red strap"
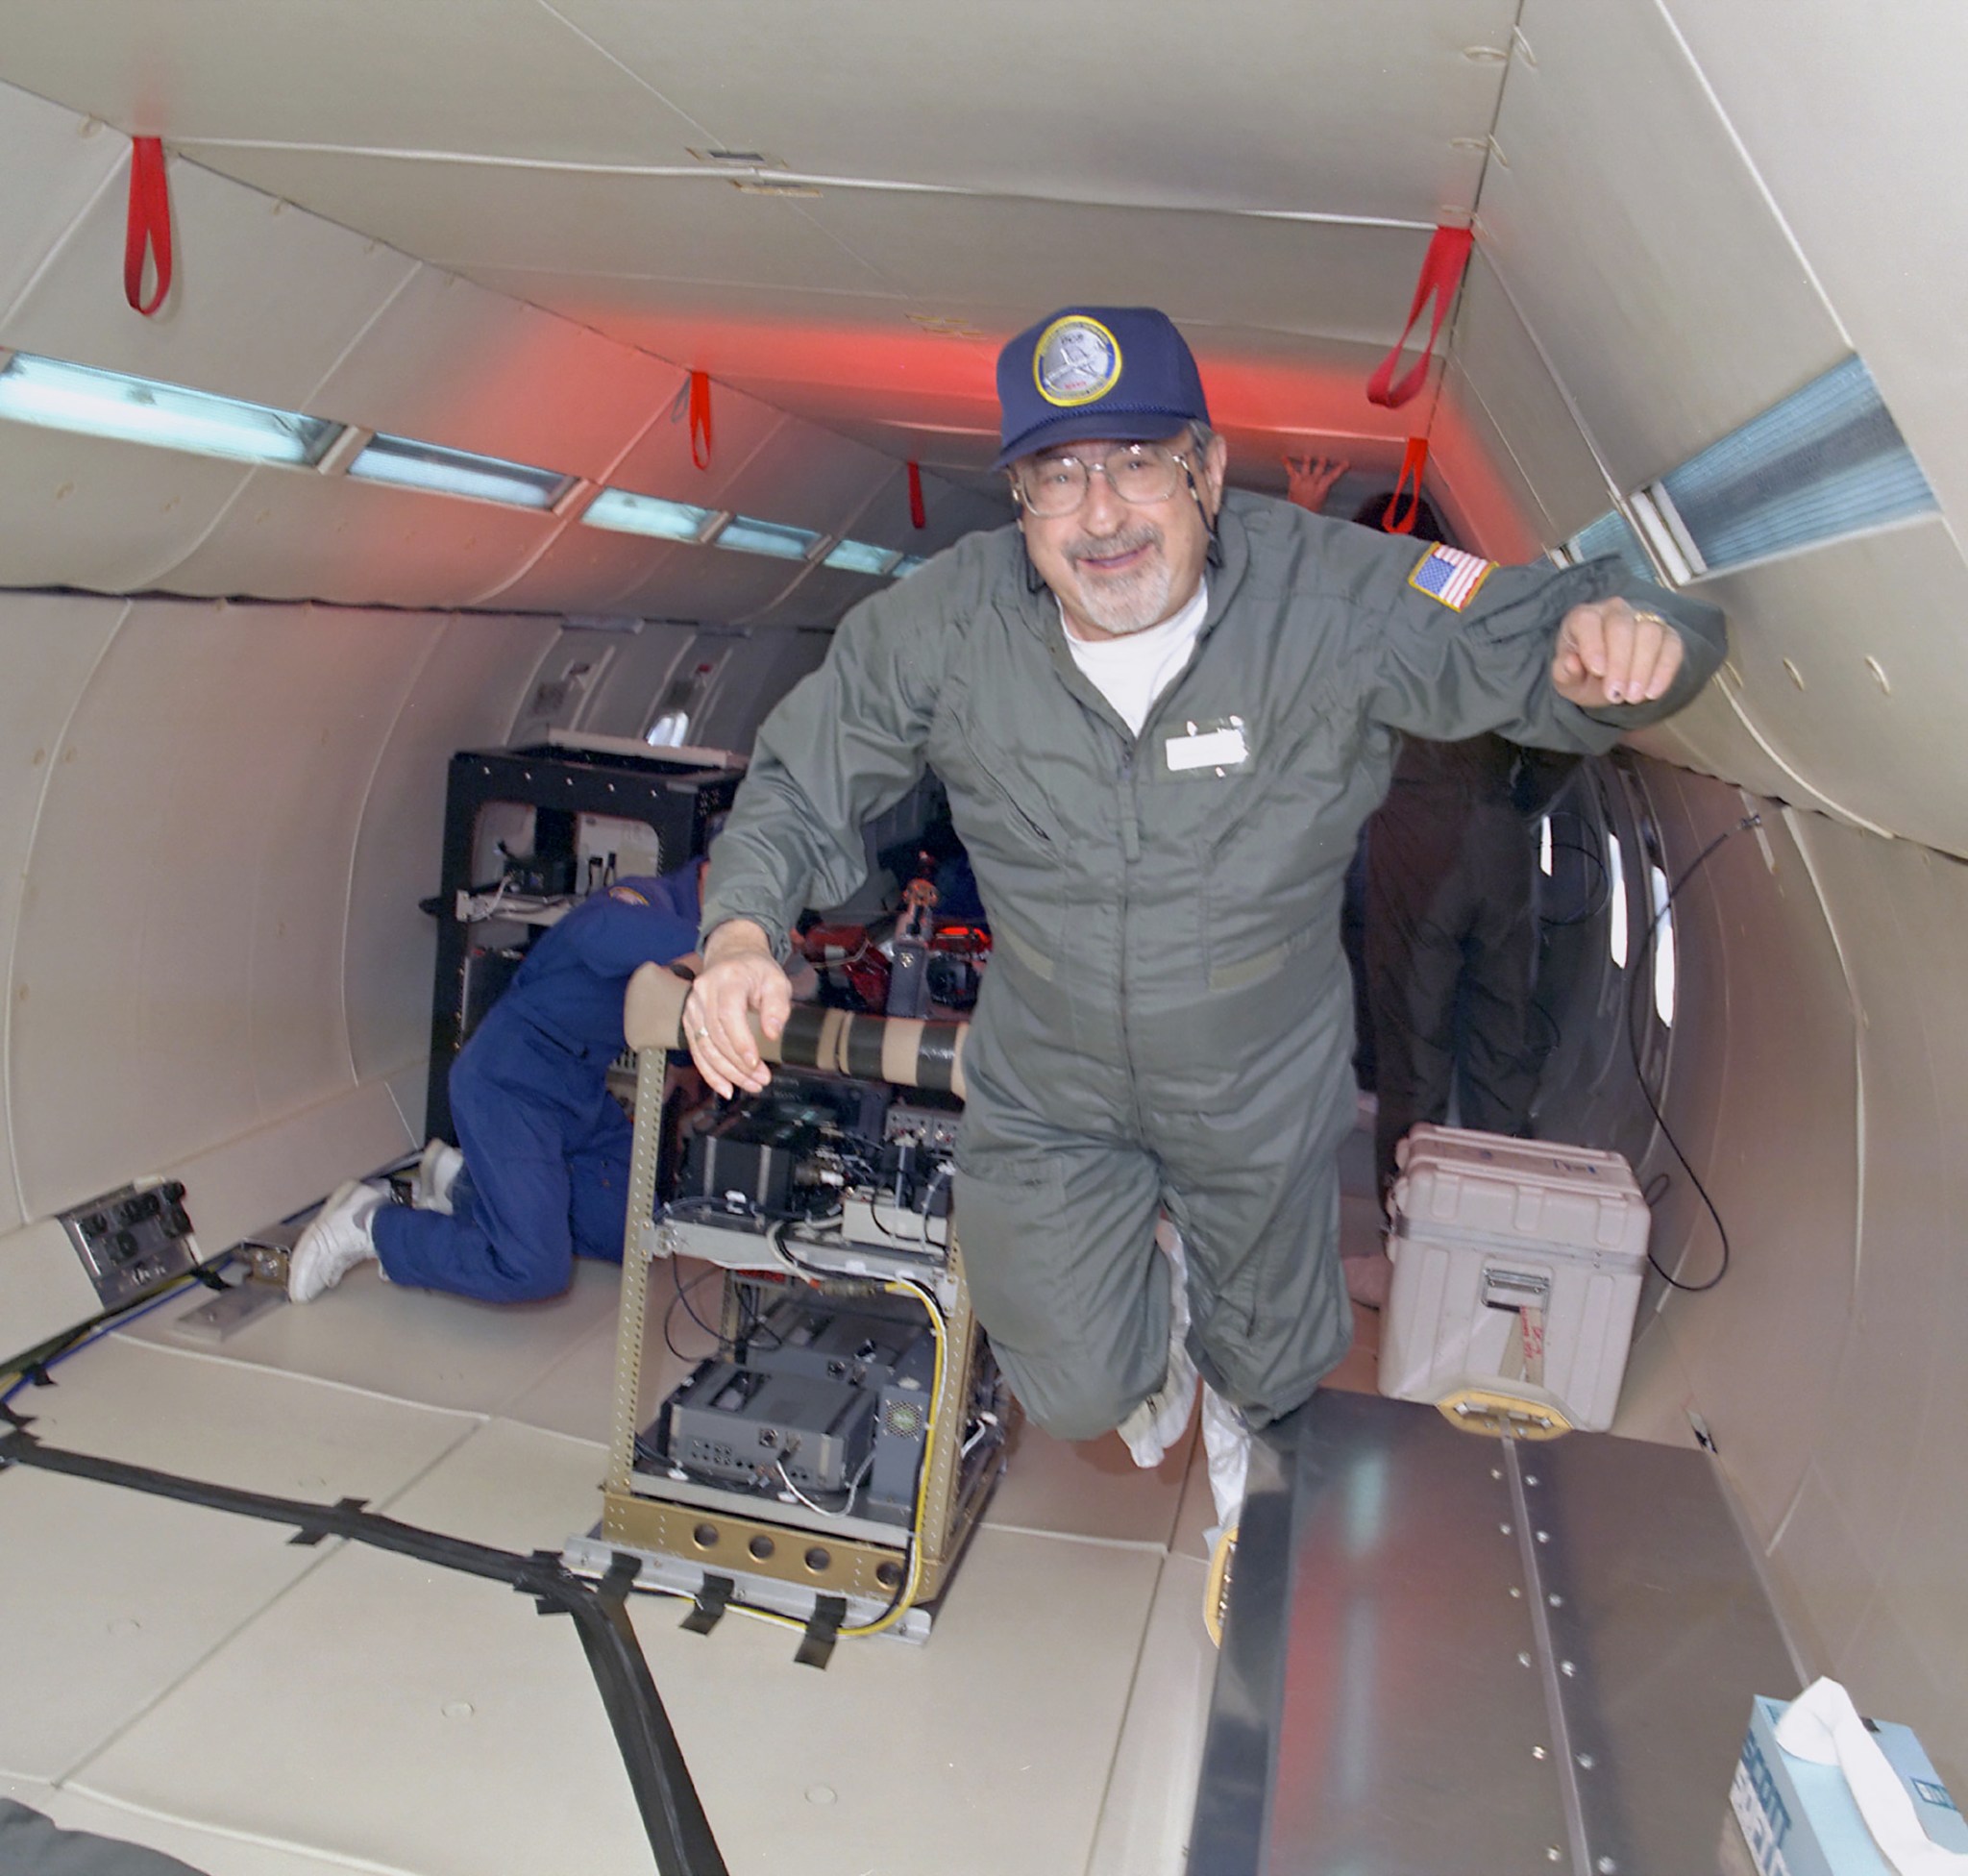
[165,141,897,293]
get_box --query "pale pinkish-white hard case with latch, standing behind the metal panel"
[1380,1124,1651,1431]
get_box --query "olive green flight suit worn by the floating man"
[704,492,1724,1439]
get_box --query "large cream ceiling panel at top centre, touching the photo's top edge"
[539,0,1515,220]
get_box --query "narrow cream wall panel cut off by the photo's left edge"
[0,593,126,1236]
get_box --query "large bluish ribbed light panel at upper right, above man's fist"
[1645,357,1934,573]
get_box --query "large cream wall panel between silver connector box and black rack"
[8,601,429,1215]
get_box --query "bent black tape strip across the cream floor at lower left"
[0,1427,730,1876]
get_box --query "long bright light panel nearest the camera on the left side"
[0,353,342,466]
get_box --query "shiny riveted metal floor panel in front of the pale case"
[1191,1394,1797,1876]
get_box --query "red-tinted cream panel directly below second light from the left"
[158,468,561,606]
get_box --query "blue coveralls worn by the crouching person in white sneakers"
[376,860,699,1303]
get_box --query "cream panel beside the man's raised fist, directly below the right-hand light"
[1696,520,1968,856]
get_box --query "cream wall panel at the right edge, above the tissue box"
[1765,817,1968,1780]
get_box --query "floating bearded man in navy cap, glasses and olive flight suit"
[685,308,1724,1514]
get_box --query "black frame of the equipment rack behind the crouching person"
[423,744,742,1140]
